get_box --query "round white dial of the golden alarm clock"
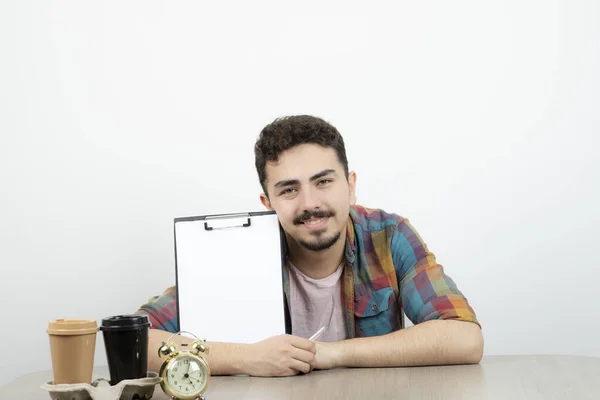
[167,355,208,396]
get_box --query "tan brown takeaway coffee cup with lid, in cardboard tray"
[46,319,99,385]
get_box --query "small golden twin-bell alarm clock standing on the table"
[158,331,210,400]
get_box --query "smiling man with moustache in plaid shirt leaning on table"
[138,116,483,376]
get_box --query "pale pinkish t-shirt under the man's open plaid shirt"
[288,262,348,342]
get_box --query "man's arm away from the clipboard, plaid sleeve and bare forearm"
[315,218,483,369]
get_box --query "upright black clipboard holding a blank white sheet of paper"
[174,211,289,343]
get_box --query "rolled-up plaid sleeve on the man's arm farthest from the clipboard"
[391,218,481,327]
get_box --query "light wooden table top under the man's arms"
[0,355,600,400]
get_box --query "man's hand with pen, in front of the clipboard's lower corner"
[245,335,316,376]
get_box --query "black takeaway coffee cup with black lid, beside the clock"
[100,315,150,386]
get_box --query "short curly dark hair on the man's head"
[254,115,348,194]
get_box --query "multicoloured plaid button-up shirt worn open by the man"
[137,206,481,338]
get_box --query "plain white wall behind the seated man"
[0,0,600,383]
